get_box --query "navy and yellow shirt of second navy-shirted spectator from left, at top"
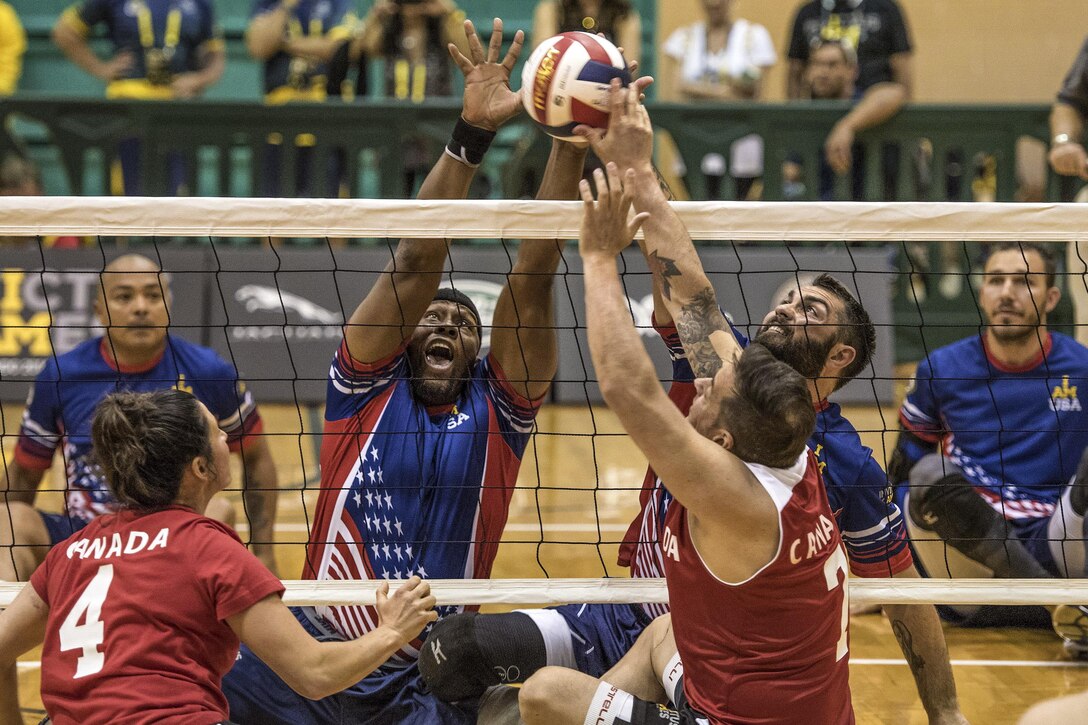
[250,0,355,94]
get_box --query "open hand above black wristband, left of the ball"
[449,17,526,131]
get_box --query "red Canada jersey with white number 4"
[30,507,284,725]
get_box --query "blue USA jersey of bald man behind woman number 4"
[15,336,262,520]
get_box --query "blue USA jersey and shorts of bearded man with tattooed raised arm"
[555,325,914,677]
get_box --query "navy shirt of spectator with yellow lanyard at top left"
[64,0,223,78]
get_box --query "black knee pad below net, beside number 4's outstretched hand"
[419,612,547,702]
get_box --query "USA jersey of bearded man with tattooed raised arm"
[619,325,914,616]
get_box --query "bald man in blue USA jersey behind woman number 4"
[0,255,279,714]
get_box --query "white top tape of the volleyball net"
[0,197,1088,242]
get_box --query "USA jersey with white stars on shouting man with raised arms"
[302,343,541,664]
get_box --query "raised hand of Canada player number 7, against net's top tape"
[578,161,650,258]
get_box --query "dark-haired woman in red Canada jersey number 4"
[0,390,437,725]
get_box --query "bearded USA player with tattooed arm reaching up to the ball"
[420,78,964,724]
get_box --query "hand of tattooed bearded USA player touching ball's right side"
[574,77,654,170]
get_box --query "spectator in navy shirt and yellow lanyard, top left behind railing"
[53,0,226,195]
